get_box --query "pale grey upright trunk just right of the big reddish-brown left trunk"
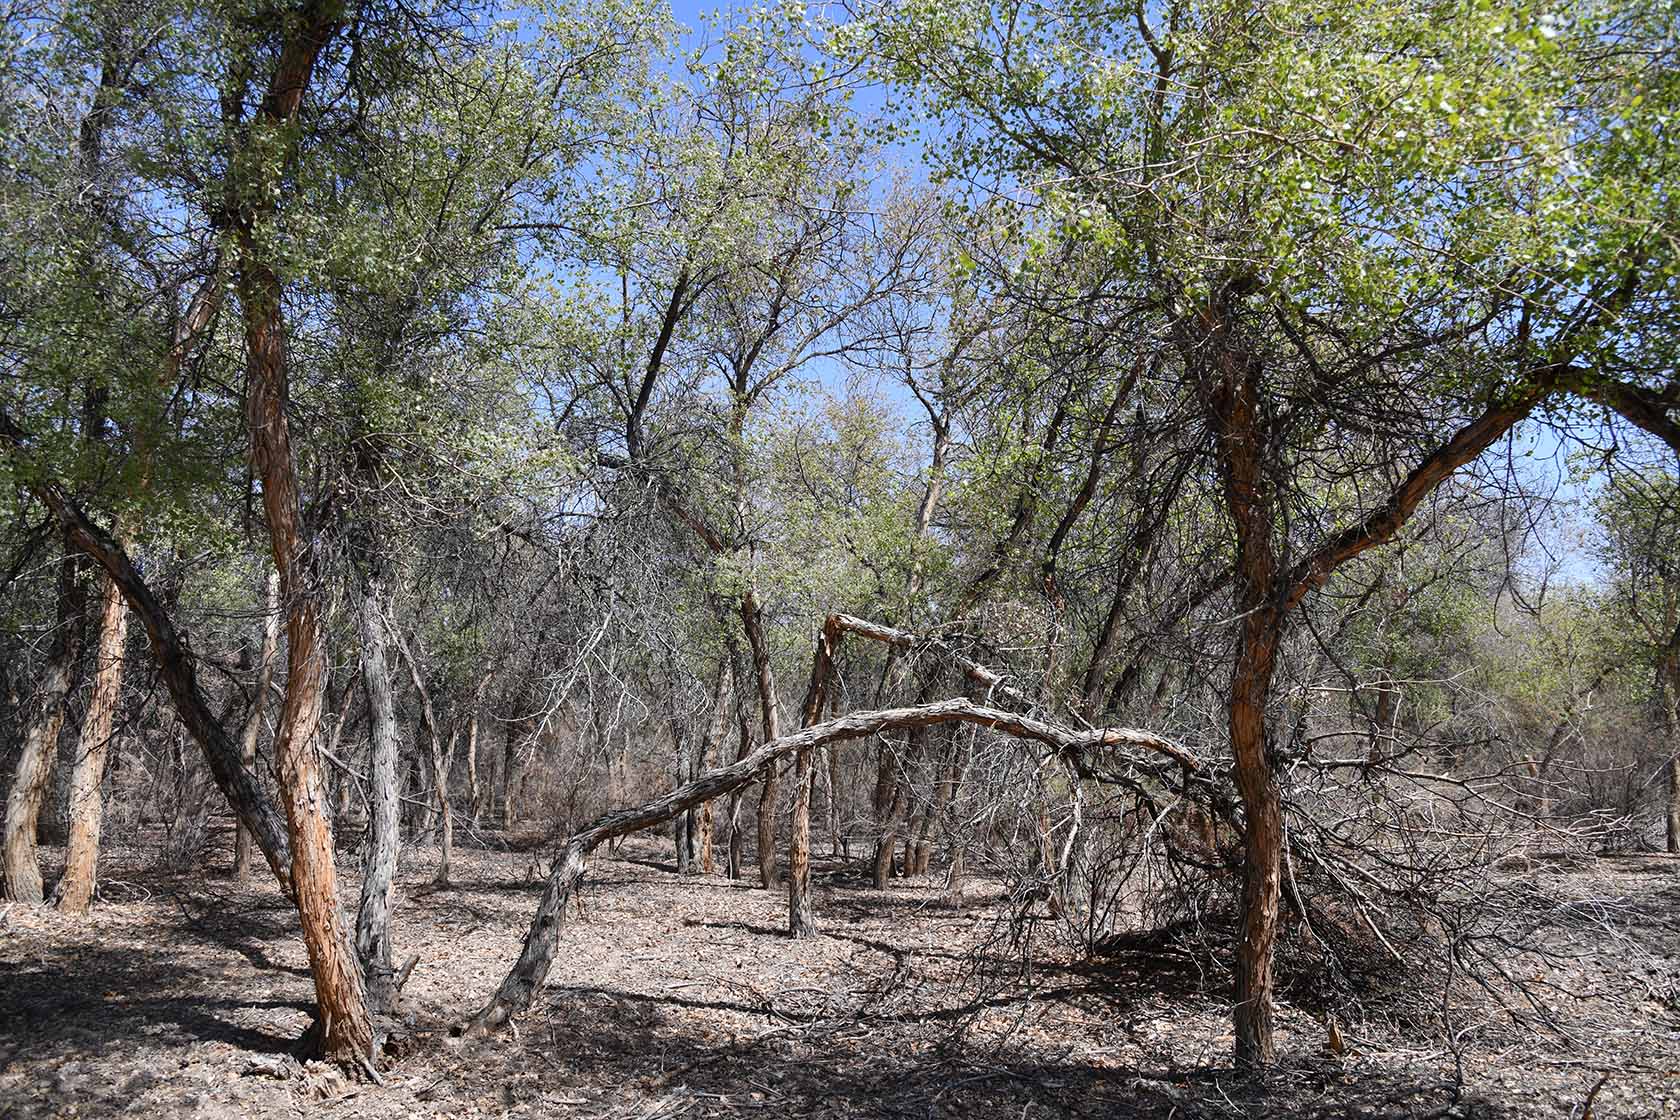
[356,576,402,1014]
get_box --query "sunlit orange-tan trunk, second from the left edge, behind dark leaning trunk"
[54,564,128,913]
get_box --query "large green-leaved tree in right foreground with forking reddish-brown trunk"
[860,2,1673,1066]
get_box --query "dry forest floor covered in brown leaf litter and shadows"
[0,838,1680,1120]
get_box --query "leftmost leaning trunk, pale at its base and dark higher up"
[0,549,82,902]
